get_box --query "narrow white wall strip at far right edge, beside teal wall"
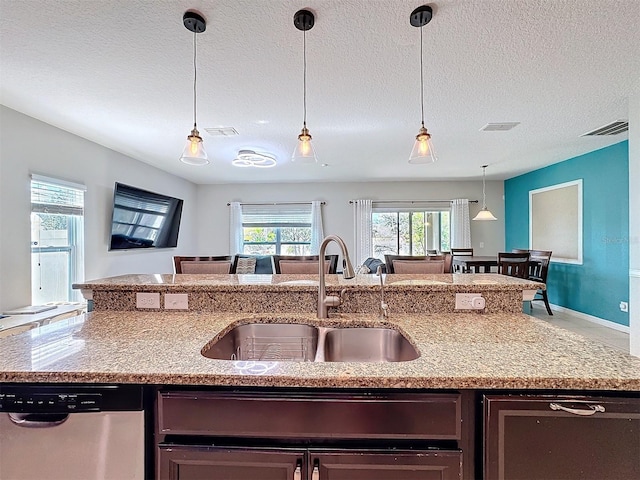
[629,85,640,357]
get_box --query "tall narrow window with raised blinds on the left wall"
[31,175,85,305]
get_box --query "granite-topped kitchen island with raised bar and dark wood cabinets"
[0,275,640,479]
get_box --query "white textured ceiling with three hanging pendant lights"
[0,0,640,183]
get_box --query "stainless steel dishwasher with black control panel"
[0,384,145,480]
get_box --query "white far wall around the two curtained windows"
[194,182,504,255]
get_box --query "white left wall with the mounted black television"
[0,106,198,311]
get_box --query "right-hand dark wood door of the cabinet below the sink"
[309,451,462,480]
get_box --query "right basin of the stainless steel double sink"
[324,327,420,362]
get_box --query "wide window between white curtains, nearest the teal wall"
[371,207,451,258]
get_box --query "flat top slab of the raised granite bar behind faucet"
[73,273,545,292]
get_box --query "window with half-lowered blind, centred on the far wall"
[242,203,312,255]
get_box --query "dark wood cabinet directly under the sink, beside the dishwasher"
[156,389,473,480]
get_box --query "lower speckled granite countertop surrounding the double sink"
[0,311,640,391]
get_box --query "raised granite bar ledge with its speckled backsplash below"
[74,274,545,314]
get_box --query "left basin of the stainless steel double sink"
[202,323,318,362]
